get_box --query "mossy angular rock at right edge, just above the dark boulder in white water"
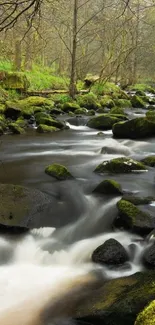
[117,199,155,235]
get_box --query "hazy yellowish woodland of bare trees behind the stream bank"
[0,0,155,97]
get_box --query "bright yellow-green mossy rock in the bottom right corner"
[135,300,155,325]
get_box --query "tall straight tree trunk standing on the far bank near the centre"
[69,0,78,98]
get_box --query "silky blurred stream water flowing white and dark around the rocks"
[0,116,155,325]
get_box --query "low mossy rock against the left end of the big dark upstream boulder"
[87,114,122,130]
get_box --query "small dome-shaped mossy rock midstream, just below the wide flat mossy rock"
[93,179,122,196]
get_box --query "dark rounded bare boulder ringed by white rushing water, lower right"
[92,238,128,266]
